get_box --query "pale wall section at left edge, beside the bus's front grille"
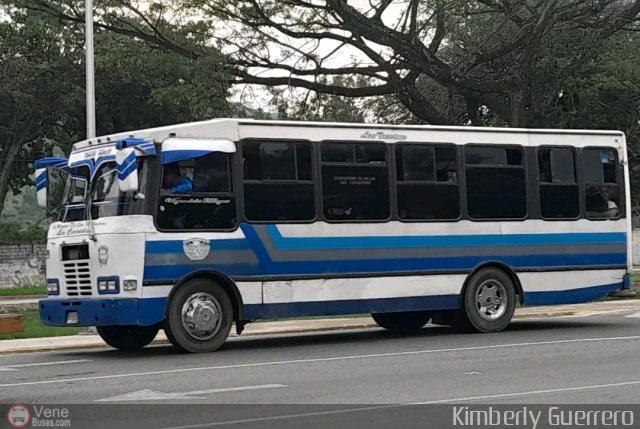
[0,244,47,289]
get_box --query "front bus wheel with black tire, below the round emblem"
[165,279,233,353]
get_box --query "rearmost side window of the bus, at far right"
[582,148,624,219]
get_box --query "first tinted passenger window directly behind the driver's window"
[242,141,315,221]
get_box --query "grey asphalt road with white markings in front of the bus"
[0,313,640,427]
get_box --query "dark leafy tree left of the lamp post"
[0,7,78,213]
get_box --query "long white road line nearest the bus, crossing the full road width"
[0,335,640,388]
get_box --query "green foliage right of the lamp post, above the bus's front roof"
[91,31,229,135]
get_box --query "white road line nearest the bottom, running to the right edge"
[163,380,640,429]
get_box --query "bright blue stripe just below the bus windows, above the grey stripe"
[262,225,627,250]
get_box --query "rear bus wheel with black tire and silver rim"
[453,267,516,333]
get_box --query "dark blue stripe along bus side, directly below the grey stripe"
[144,253,626,281]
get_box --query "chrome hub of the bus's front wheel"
[182,292,222,341]
